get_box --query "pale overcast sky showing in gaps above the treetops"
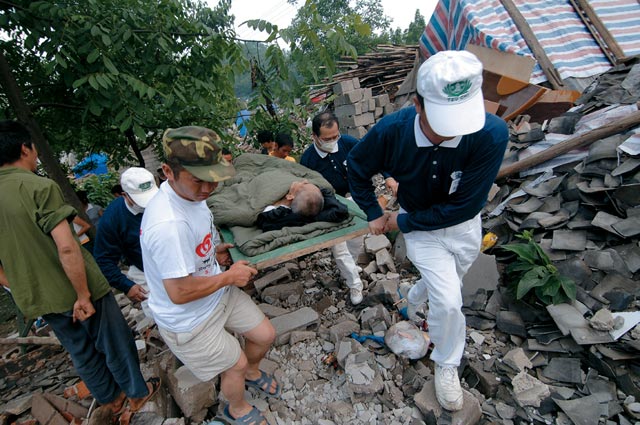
[208,0,437,43]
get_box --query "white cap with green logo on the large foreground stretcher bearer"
[416,50,485,137]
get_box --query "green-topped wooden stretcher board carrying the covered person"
[220,196,369,270]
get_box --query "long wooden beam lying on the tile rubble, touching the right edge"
[496,111,640,179]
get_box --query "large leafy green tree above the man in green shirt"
[0,0,244,170]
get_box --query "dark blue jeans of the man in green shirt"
[43,292,149,404]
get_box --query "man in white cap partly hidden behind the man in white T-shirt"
[93,167,158,302]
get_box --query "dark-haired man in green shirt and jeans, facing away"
[0,121,159,420]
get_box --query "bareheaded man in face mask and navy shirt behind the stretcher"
[300,112,362,305]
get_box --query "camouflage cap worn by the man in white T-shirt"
[162,126,236,182]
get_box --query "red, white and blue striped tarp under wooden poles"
[420,0,640,83]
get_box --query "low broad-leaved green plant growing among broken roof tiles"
[502,230,576,305]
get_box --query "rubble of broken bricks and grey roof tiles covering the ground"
[0,58,640,425]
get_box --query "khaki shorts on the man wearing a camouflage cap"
[158,286,265,381]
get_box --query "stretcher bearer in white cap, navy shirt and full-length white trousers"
[348,51,509,410]
